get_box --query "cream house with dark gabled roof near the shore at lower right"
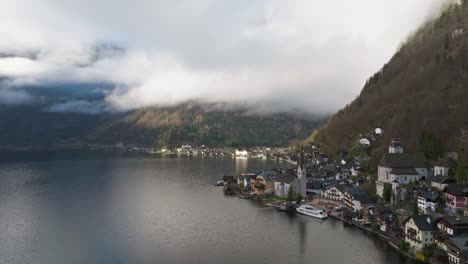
[403,215,436,250]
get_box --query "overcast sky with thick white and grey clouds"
[0,0,446,113]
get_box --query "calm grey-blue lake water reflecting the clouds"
[0,157,405,264]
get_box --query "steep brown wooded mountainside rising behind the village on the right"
[311,1,468,160]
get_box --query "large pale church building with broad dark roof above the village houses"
[376,153,428,197]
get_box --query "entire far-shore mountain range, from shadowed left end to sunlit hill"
[0,104,320,148]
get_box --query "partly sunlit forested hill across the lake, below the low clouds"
[80,104,319,147]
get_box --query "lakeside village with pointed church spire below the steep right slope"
[217,138,468,264]
